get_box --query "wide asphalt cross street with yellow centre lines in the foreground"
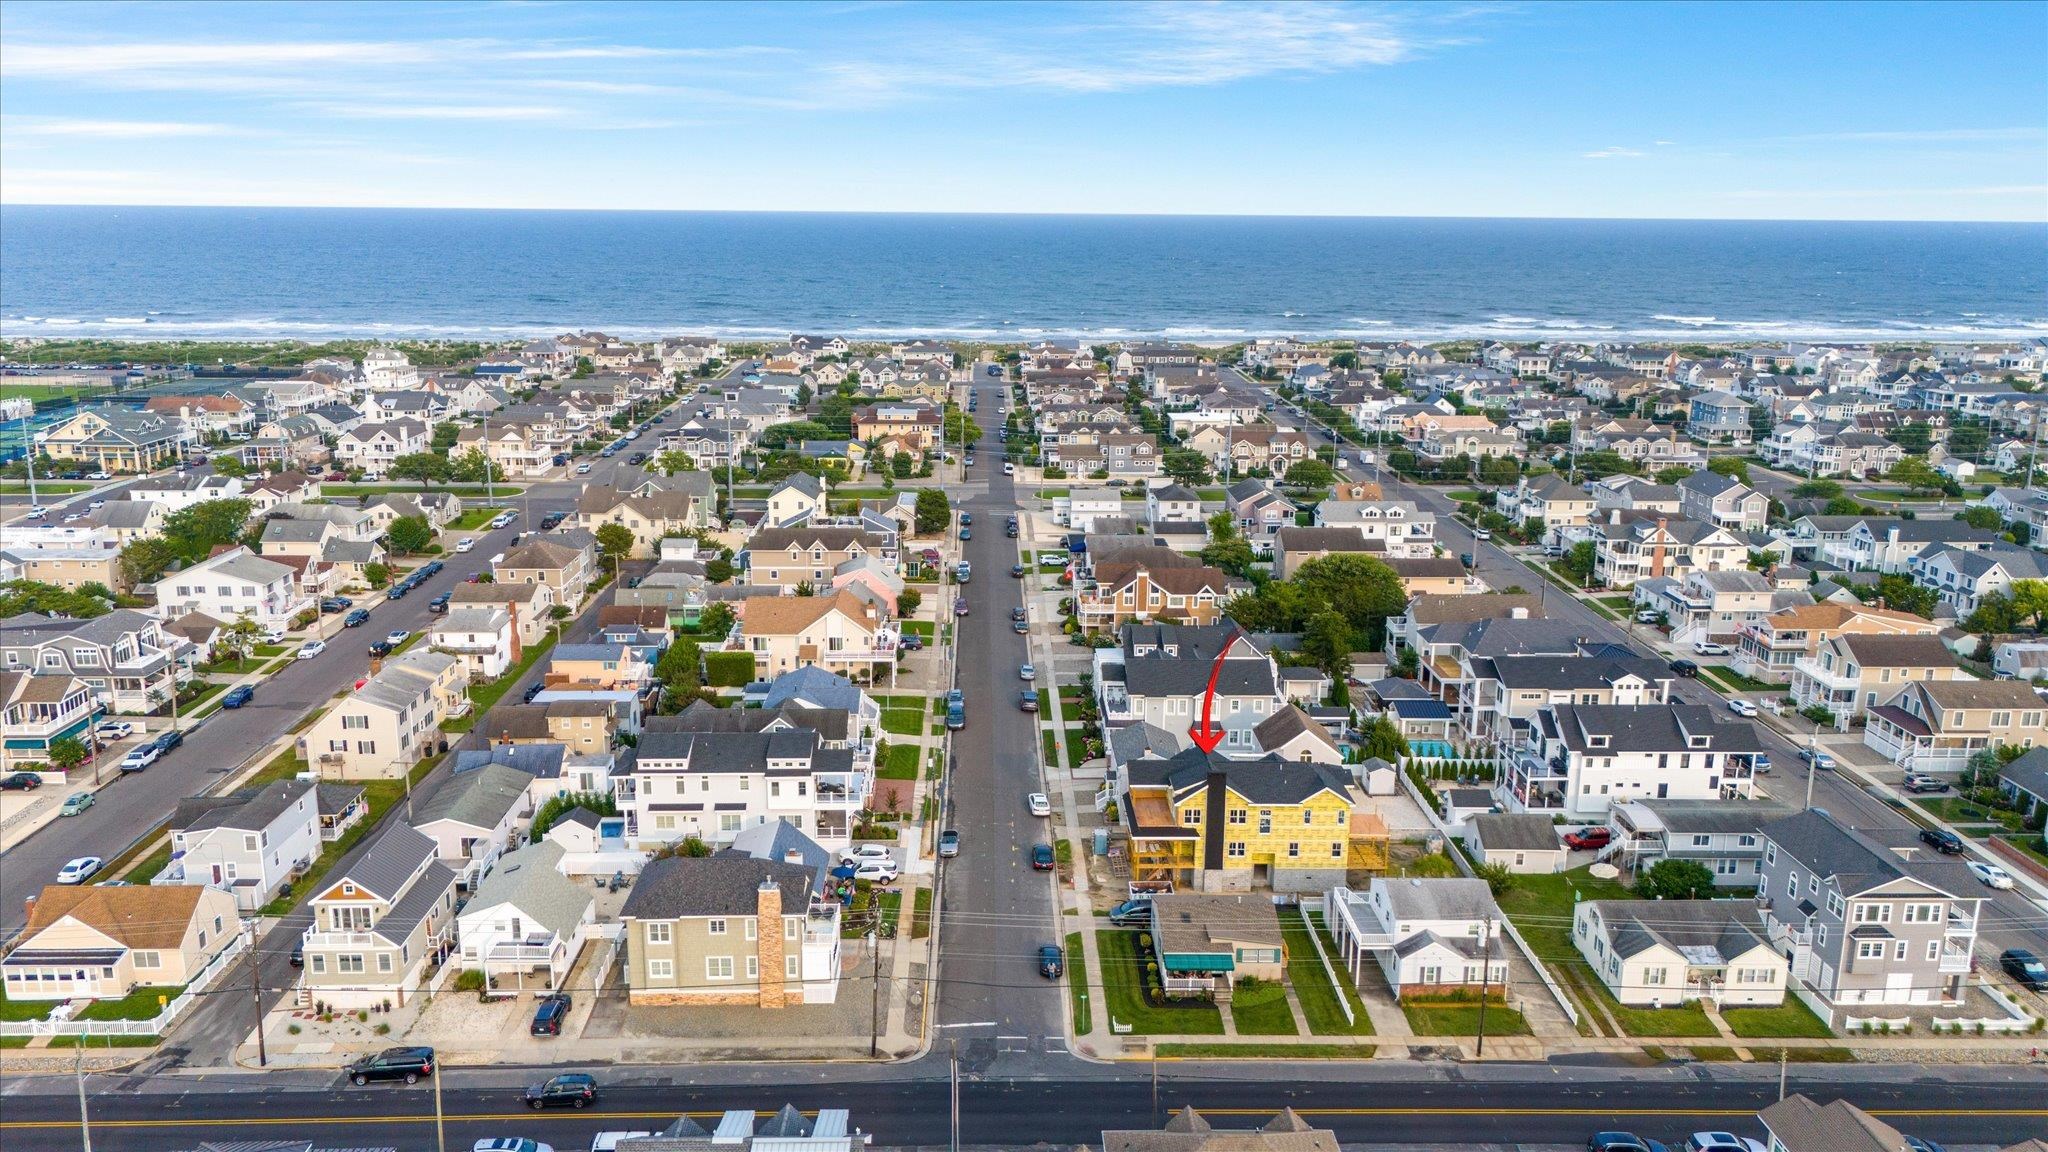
[0,1060,2048,1152]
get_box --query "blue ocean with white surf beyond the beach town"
[0,205,2048,342]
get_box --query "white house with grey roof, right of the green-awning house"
[1323,877,1507,1000]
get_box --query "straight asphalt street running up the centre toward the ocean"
[932,375,1065,1054]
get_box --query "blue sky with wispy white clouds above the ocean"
[0,2,2048,221]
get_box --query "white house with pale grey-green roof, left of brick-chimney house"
[455,840,598,992]
